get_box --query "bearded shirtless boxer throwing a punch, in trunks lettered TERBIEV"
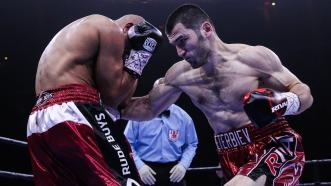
[122,5,313,186]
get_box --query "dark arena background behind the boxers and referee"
[0,0,331,185]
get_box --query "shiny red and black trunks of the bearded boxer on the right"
[215,118,305,185]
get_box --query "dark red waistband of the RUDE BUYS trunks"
[32,84,100,111]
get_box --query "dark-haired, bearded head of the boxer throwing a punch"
[165,4,215,68]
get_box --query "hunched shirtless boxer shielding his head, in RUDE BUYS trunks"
[27,15,162,186]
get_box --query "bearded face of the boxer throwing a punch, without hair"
[168,23,208,68]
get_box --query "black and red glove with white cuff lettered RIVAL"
[243,88,300,127]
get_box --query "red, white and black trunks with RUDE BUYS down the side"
[27,84,140,186]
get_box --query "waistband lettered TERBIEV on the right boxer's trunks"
[214,118,290,152]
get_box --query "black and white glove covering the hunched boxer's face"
[124,21,162,78]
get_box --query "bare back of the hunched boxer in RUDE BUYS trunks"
[36,17,98,94]
